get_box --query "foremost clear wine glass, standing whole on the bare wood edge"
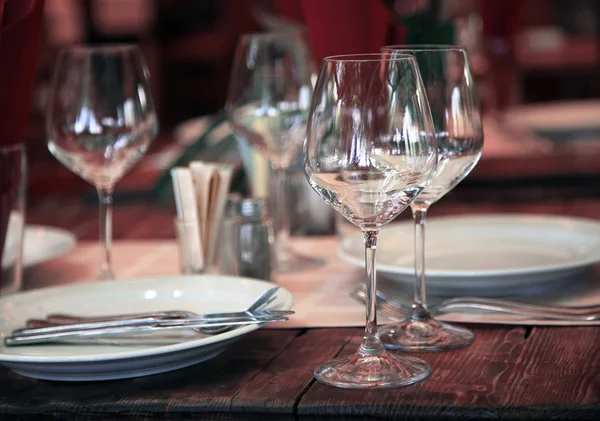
[303,53,437,388]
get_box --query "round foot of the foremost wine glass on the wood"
[314,351,431,389]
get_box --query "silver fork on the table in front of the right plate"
[350,284,600,321]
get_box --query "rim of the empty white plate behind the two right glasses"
[337,213,600,278]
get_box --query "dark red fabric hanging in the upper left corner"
[0,0,44,145]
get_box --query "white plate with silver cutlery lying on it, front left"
[0,275,292,381]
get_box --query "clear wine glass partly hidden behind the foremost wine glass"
[381,45,483,351]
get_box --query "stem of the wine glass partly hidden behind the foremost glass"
[411,204,429,319]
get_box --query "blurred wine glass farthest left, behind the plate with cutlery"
[46,45,158,280]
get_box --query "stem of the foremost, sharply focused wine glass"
[358,231,384,357]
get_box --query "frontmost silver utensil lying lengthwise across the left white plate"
[4,315,288,346]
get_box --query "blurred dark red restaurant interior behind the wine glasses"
[27,0,600,229]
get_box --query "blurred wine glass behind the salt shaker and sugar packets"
[225,31,322,272]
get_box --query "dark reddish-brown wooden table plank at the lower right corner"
[298,326,600,420]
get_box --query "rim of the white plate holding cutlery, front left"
[0,274,293,364]
